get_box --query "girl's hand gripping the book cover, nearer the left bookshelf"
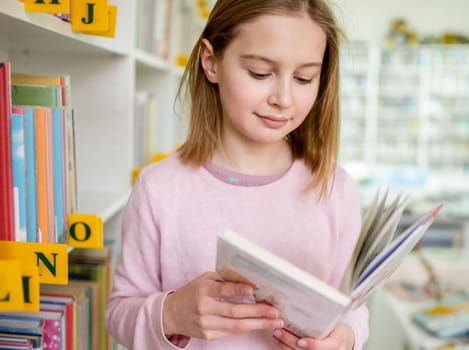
[163,272,284,339]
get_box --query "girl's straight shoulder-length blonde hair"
[178,0,342,198]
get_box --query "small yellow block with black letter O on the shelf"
[68,214,103,249]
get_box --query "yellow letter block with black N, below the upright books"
[0,241,68,284]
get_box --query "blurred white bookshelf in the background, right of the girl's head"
[341,42,469,189]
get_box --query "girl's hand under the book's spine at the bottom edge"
[274,323,355,350]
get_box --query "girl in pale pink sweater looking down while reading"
[106,0,368,350]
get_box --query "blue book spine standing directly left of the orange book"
[24,108,37,242]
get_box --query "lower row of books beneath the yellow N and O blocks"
[0,245,112,350]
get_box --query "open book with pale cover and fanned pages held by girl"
[216,194,442,338]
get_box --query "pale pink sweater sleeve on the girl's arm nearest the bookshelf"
[106,171,187,350]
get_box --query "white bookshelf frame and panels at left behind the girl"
[0,0,194,231]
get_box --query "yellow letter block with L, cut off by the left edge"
[0,260,24,311]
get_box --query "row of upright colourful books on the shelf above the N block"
[0,63,77,243]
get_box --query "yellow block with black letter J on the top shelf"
[71,0,109,32]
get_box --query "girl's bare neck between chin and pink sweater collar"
[212,141,293,176]
